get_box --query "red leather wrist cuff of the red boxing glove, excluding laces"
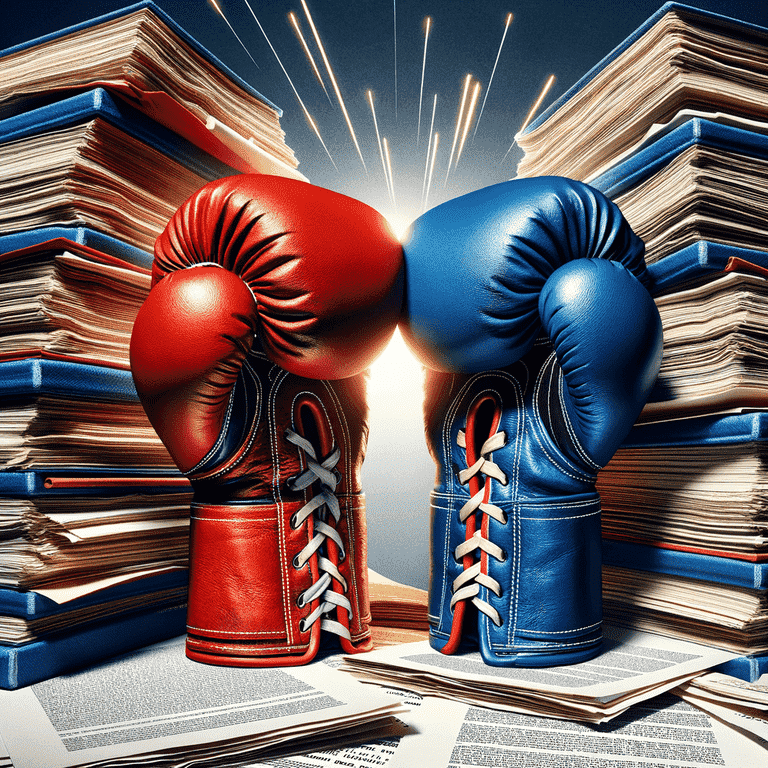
[187,495,370,666]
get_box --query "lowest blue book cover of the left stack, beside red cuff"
[0,605,187,690]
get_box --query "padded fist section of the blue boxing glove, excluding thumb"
[401,177,649,372]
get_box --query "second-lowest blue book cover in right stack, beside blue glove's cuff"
[603,539,768,590]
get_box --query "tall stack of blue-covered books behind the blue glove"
[518,3,768,680]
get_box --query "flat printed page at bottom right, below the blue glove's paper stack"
[388,694,768,768]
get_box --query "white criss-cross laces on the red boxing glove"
[285,429,352,640]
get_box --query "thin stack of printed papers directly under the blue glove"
[343,627,733,723]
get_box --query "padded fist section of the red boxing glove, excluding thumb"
[153,174,403,379]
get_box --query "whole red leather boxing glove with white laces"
[131,175,402,666]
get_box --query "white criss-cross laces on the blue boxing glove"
[450,430,507,627]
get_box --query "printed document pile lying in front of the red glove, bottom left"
[0,637,405,768]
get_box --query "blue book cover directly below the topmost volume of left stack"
[0,88,236,181]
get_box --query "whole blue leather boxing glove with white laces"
[401,177,662,666]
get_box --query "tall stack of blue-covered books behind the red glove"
[0,2,303,689]
